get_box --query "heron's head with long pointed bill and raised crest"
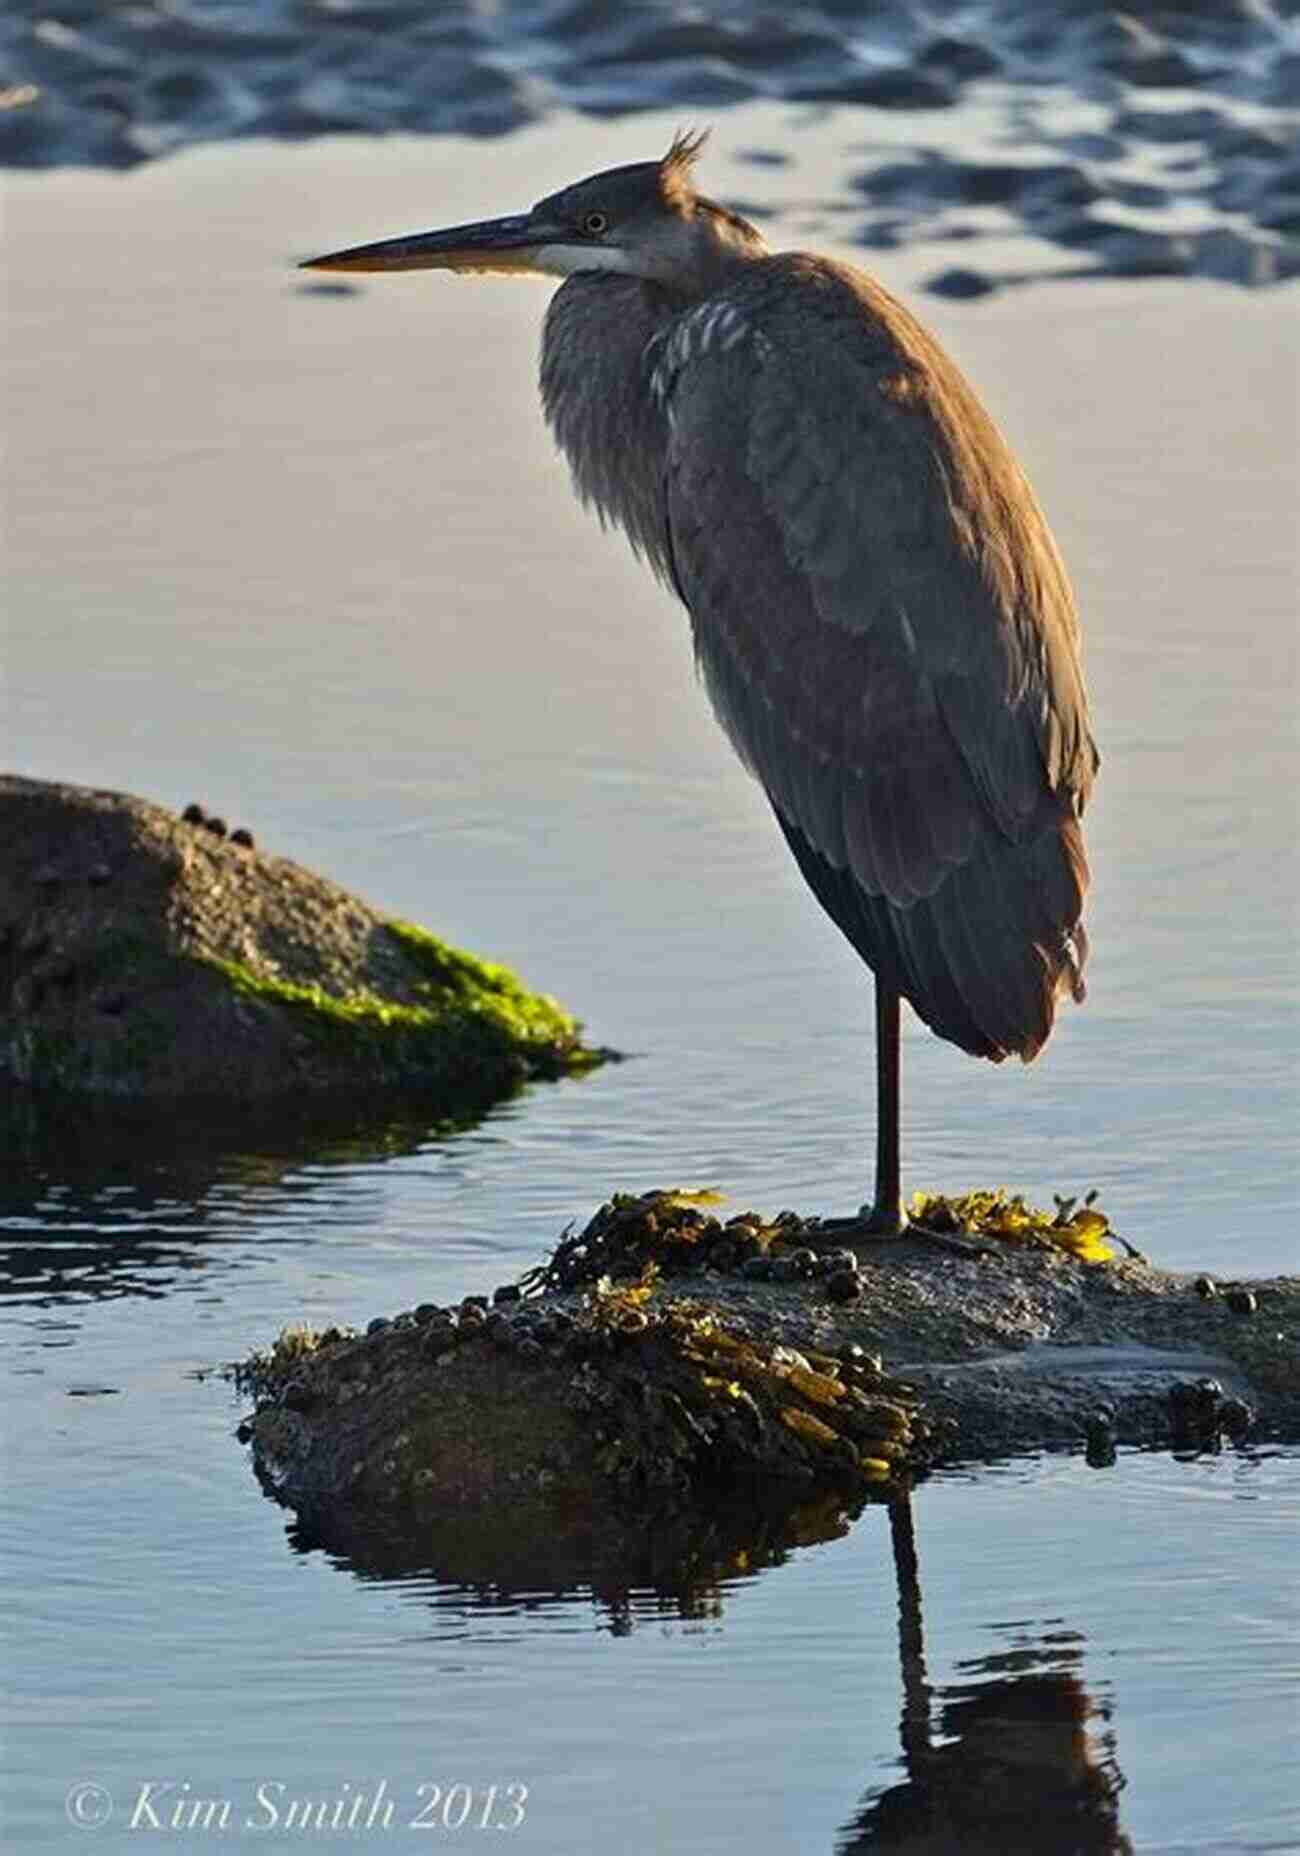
[303,135,767,297]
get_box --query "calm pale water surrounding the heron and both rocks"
[0,119,1300,1852]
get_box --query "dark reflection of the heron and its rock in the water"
[282,1455,1131,1856]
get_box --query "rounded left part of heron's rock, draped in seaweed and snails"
[238,1266,930,1529]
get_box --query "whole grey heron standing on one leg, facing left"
[308,135,1098,1234]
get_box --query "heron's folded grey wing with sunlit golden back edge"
[657,260,1094,1054]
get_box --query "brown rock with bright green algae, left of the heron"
[0,776,605,1114]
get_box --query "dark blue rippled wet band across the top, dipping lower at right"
[0,0,1300,297]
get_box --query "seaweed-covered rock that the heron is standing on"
[238,1192,1300,1514]
